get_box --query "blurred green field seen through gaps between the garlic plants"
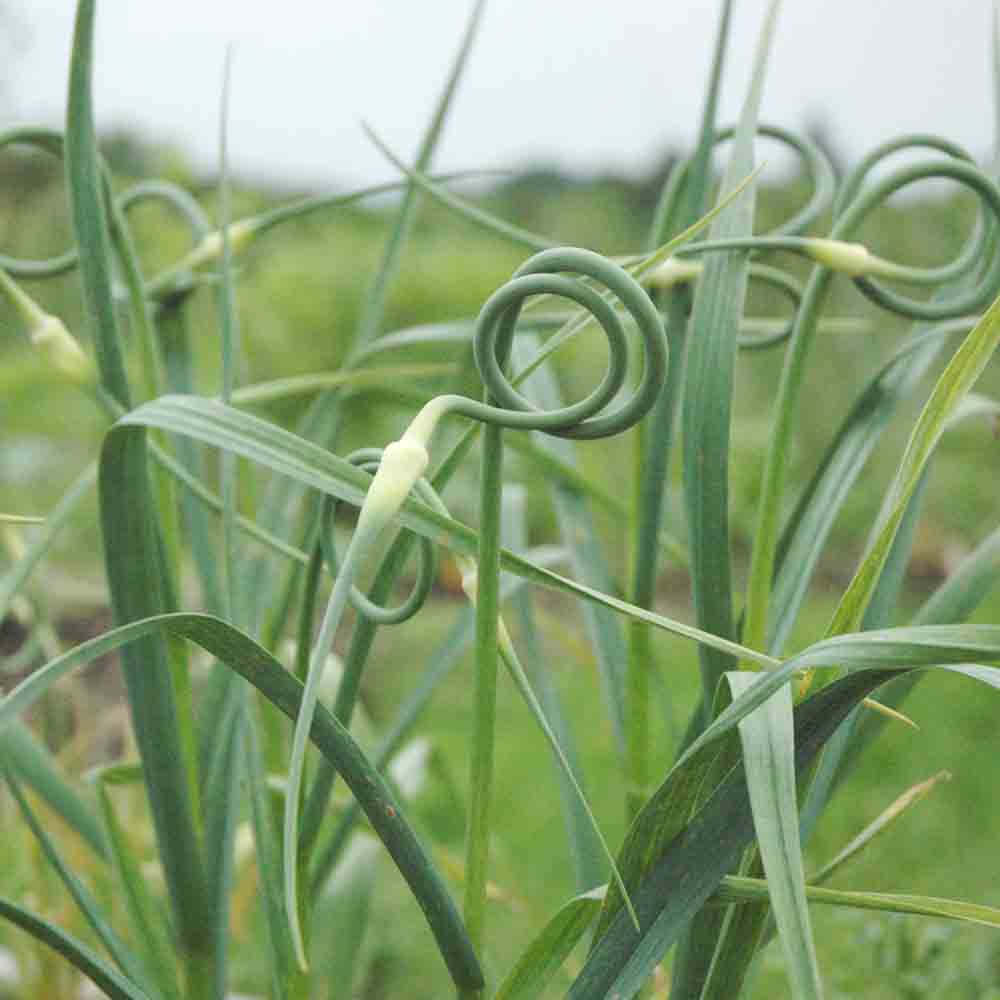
[0,136,1000,1000]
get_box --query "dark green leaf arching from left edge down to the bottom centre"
[0,612,482,989]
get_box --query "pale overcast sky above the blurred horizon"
[4,0,993,186]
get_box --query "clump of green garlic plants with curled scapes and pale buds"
[0,0,1000,1000]
